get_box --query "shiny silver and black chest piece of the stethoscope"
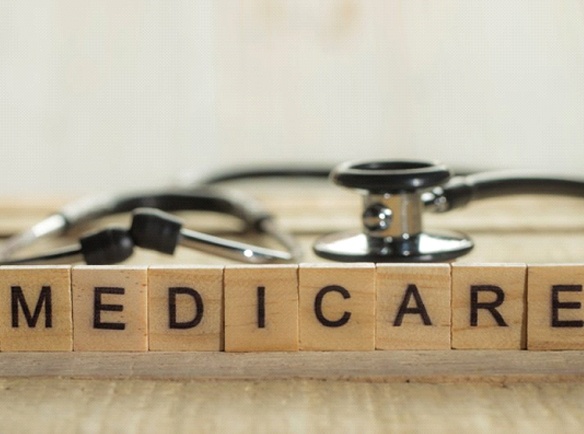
[313,161,473,262]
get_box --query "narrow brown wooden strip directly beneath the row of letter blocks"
[0,350,584,383]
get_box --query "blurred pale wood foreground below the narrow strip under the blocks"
[0,378,584,434]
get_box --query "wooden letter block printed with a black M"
[0,266,73,351]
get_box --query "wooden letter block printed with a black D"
[148,266,223,351]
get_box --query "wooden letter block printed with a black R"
[452,264,527,349]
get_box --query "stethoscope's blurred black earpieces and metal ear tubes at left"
[0,186,300,265]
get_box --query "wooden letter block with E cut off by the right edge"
[527,265,584,350]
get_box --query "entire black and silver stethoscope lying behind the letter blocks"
[0,160,584,265]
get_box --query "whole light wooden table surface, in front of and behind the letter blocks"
[0,182,584,433]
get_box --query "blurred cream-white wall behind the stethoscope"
[0,0,584,195]
